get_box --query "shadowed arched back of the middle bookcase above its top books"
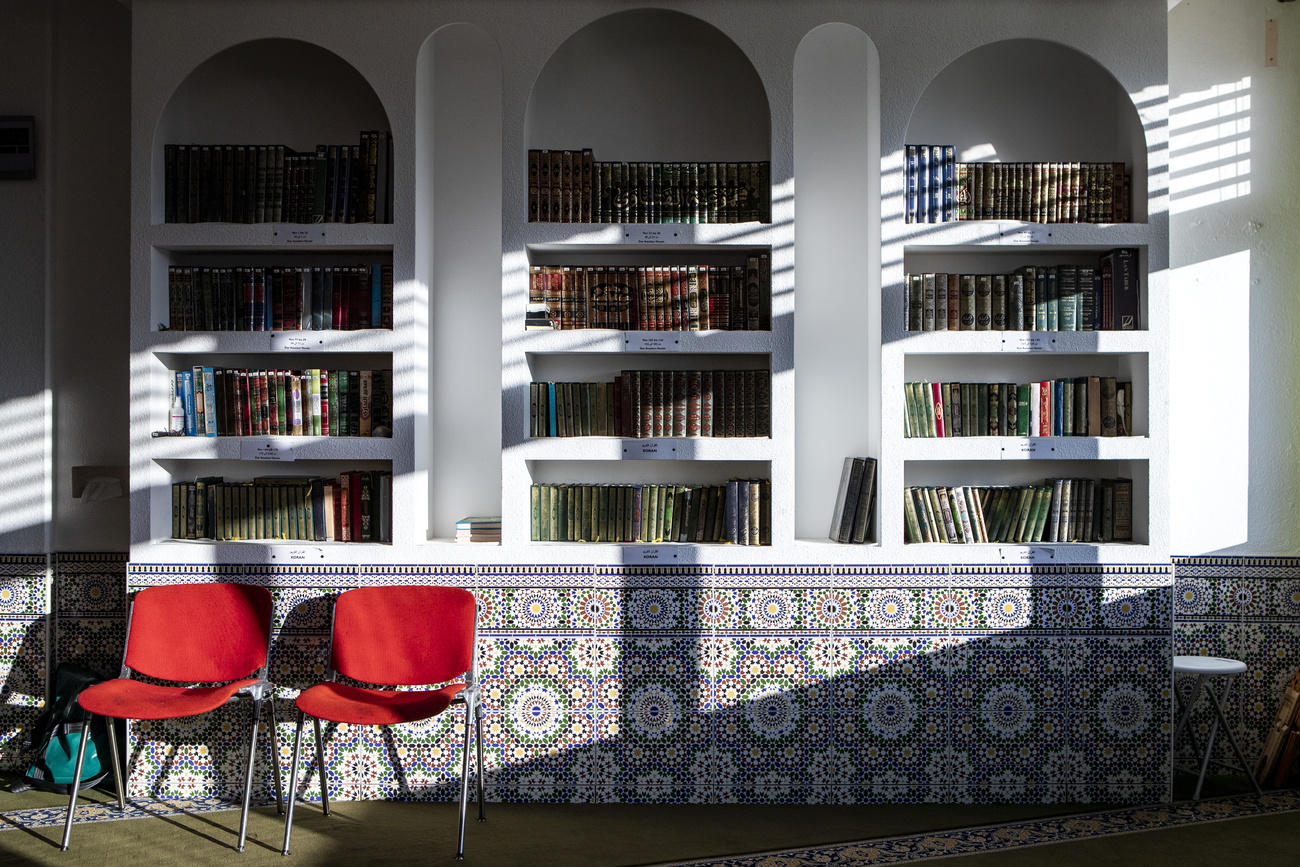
[524,9,771,161]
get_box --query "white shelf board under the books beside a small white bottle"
[146,437,398,468]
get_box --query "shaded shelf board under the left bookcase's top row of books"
[143,222,395,253]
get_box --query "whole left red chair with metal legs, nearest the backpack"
[62,584,285,851]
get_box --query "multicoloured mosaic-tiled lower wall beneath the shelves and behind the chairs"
[0,555,1300,802]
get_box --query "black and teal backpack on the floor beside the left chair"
[10,663,112,794]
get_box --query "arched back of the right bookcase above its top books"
[906,39,1147,222]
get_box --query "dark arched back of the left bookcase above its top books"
[152,39,391,222]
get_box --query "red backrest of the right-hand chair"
[330,586,476,686]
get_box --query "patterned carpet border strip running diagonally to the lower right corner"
[662,789,1300,867]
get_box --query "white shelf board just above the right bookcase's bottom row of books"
[902,437,1151,460]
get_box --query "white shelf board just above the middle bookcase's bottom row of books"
[508,437,774,460]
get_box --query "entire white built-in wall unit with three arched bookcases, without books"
[124,0,1167,565]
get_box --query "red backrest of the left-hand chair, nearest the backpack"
[126,584,270,682]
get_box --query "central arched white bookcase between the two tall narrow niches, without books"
[501,9,792,563]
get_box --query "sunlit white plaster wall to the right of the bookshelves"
[1169,0,1300,555]
